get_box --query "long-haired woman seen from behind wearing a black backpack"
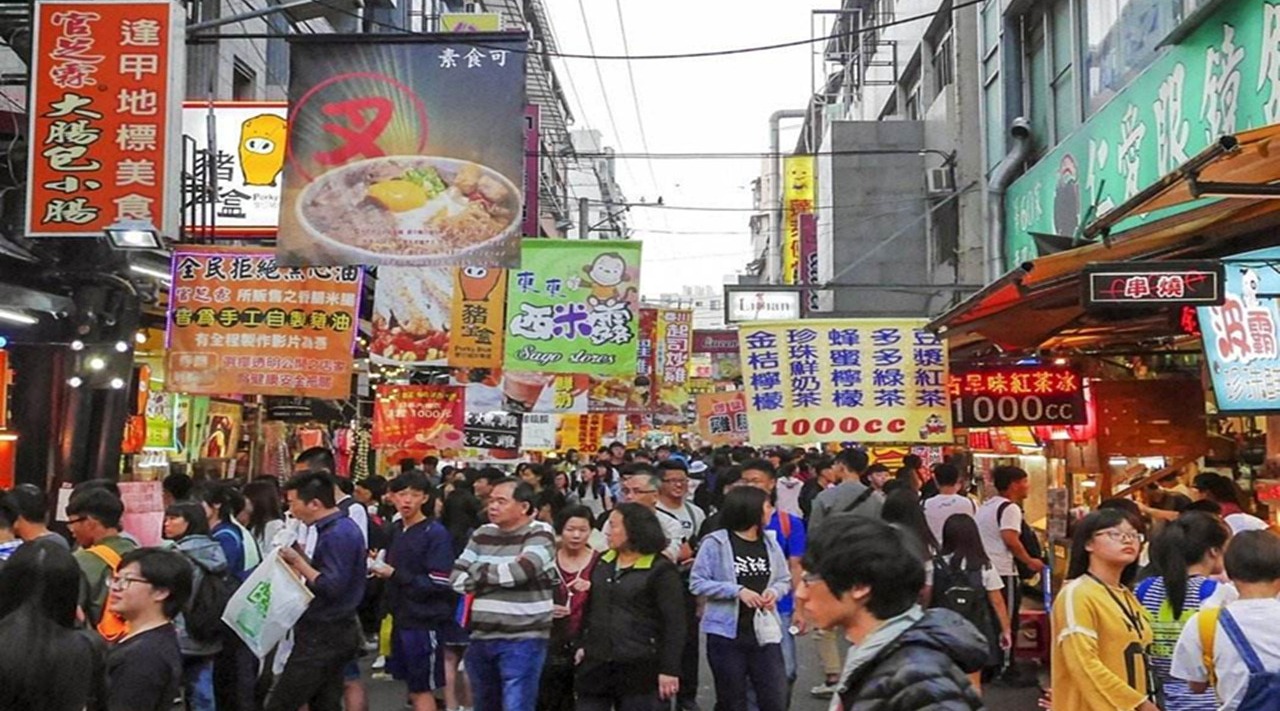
[929,516,1014,693]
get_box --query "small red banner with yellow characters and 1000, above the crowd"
[372,386,466,450]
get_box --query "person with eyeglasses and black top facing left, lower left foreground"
[106,548,192,711]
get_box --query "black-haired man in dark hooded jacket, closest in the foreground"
[796,514,988,711]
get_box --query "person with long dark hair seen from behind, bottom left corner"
[0,541,105,711]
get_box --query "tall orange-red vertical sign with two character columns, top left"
[26,0,186,237]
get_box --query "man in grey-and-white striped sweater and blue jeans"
[451,478,556,711]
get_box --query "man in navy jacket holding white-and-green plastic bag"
[266,471,367,711]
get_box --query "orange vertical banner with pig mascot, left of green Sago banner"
[449,266,507,369]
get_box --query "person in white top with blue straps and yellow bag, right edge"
[1171,530,1280,711]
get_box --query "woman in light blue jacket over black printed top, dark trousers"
[689,487,791,711]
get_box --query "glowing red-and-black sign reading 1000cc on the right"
[947,365,1089,427]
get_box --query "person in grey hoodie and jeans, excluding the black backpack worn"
[163,501,227,711]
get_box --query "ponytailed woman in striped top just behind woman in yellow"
[1134,511,1231,711]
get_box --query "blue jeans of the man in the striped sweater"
[463,639,547,711]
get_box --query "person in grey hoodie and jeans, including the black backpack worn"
[163,501,236,711]
